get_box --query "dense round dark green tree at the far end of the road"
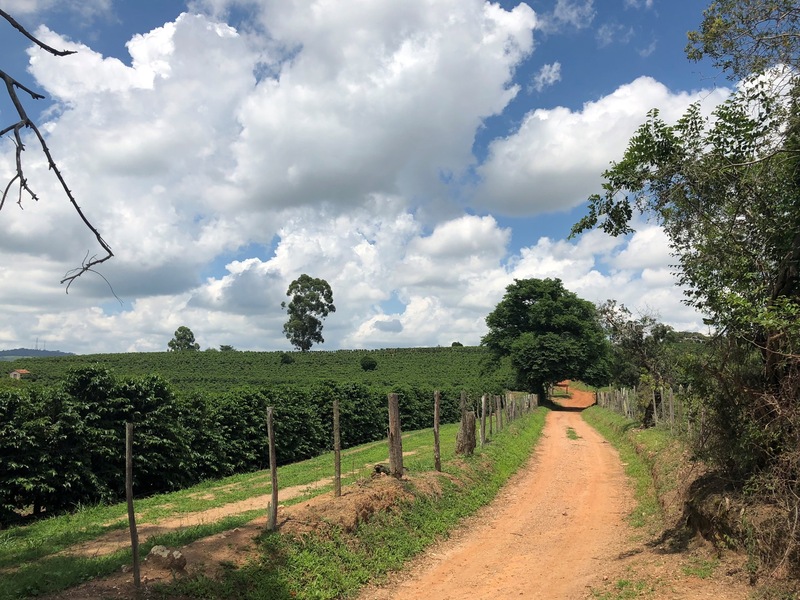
[481,279,609,397]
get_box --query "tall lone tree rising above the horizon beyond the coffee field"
[281,274,336,352]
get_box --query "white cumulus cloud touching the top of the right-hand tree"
[476,77,728,215]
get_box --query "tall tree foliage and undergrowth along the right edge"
[573,0,800,576]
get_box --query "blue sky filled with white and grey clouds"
[0,0,729,353]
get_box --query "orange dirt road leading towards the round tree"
[360,392,747,600]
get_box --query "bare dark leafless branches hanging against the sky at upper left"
[0,9,114,290]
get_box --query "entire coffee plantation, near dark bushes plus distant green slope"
[0,347,520,526]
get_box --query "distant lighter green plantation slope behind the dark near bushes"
[7,346,510,395]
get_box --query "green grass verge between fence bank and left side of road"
[159,409,547,600]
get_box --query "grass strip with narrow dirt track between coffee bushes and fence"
[0,425,457,600]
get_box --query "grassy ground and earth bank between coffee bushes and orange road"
[0,409,546,600]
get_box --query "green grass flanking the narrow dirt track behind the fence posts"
[0,424,472,600]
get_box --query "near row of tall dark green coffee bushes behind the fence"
[0,367,474,525]
